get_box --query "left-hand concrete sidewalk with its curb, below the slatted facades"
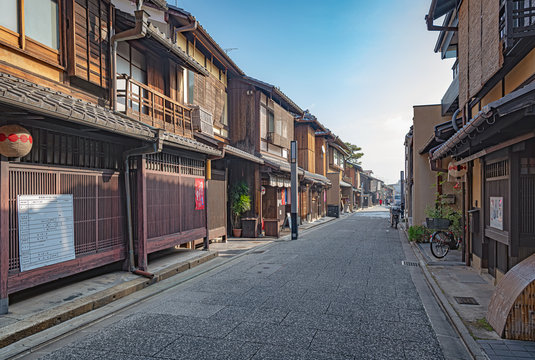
[0,214,335,352]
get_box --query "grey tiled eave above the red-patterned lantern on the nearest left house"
[0,72,156,140]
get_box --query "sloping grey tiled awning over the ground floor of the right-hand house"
[432,82,535,160]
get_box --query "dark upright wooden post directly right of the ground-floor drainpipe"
[135,155,148,271]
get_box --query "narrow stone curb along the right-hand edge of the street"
[402,230,489,360]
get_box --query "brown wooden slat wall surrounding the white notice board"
[9,164,125,273]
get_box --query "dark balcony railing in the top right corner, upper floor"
[500,0,535,51]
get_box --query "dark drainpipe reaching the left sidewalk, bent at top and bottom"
[123,129,164,279]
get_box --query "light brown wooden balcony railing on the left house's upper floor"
[117,75,193,137]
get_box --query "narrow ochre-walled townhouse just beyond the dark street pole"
[294,110,331,222]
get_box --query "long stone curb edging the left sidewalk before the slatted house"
[0,252,218,348]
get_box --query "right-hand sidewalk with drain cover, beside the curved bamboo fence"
[404,232,535,360]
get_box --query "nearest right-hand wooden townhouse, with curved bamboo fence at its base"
[427,0,535,340]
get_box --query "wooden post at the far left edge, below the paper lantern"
[0,156,9,314]
